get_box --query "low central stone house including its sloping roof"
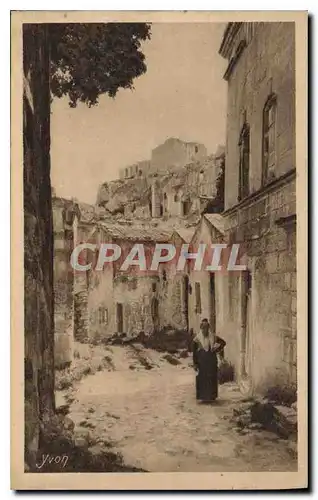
[87,222,169,339]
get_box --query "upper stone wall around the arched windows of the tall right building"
[225,22,295,209]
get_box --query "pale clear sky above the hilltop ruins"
[51,22,227,203]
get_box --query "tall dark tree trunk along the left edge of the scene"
[23,24,55,467]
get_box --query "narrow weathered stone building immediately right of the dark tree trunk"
[52,196,98,352]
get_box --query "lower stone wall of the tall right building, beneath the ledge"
[219,173,297,392]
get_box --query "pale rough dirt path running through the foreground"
[57,347,297,472]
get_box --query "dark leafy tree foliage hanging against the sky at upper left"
[49,23,150,107]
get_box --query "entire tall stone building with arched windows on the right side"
[217,22,296,392]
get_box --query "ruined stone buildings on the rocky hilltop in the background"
[96,138,224,222]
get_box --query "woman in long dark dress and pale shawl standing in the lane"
[193,318,226,403]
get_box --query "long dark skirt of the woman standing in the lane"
[196,349,218,402]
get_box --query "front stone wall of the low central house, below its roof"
[87,235,164,340]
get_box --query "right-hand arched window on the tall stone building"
[262,94,277,184]
